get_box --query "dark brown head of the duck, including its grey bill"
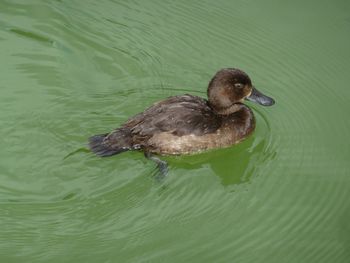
[208,68,275,114]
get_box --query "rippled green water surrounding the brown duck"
[0,0,350,263]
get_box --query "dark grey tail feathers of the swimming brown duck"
[89,133,130,157]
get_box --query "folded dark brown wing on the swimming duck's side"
[123,95,221,138]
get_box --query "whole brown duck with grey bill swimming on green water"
[89,68,275,174]
